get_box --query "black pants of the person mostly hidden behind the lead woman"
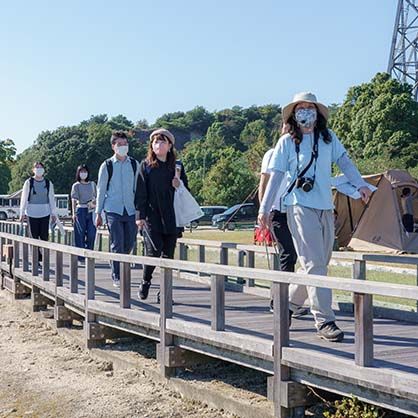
[273,210,298,272]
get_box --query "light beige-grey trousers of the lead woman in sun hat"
[287,206,335,328]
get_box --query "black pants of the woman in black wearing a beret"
[143,227,177,282]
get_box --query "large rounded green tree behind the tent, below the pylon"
[330,73,418,169]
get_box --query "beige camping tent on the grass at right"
[334,170,418,253]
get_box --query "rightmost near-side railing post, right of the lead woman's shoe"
[354,293,373,367]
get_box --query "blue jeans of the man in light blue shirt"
[106,211,138,280]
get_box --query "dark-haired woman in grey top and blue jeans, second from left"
[71,164,97,256]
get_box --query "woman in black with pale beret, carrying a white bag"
[135,128,188,300]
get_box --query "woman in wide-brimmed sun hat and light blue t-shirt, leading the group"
[258,93,371,341]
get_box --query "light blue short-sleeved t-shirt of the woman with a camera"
[268,130,346,210]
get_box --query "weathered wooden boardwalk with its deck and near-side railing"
[0,225,418,417]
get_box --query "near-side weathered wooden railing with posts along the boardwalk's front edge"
[0,226,418,417]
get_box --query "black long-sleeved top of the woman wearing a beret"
[135,160,188,234]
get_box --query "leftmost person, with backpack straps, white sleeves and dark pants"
[20,161,57,261]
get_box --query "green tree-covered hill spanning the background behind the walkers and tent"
[0,73,418,205]
